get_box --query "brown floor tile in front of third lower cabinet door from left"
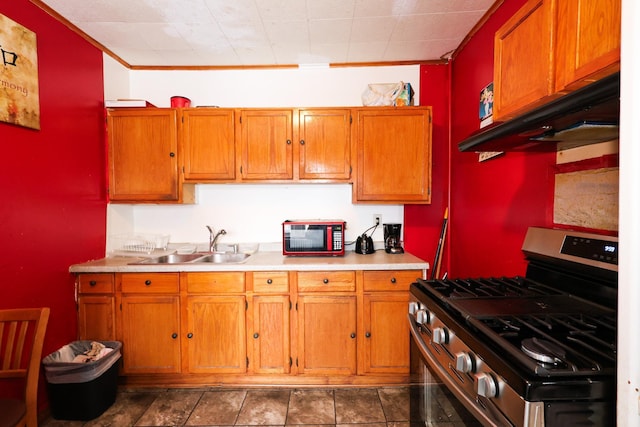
[186,390,247,426]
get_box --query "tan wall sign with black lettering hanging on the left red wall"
[0,14,40,129]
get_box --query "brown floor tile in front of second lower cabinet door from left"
[135,390,203,427]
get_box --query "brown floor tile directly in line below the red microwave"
[287,389,336,427]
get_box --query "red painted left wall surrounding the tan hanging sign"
[0,0,107,402]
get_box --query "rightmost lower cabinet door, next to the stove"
[360,292,409,374]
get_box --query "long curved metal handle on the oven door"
[408,314,514,427]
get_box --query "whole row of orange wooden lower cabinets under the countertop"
[77,270,422,385]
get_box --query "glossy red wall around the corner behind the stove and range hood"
[405,0,555,277]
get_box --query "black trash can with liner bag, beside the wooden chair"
[42,341,122,421]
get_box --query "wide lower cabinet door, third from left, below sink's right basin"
[185,295,247,373]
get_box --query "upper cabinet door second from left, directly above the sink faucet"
[181,109,236,182]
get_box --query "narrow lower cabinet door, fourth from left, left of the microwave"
[249,295,291,374]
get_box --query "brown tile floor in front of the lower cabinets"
[40,387,416,427]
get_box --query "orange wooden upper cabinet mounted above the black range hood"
[493,0,620,121]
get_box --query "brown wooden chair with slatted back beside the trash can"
[0,308,49,427]
